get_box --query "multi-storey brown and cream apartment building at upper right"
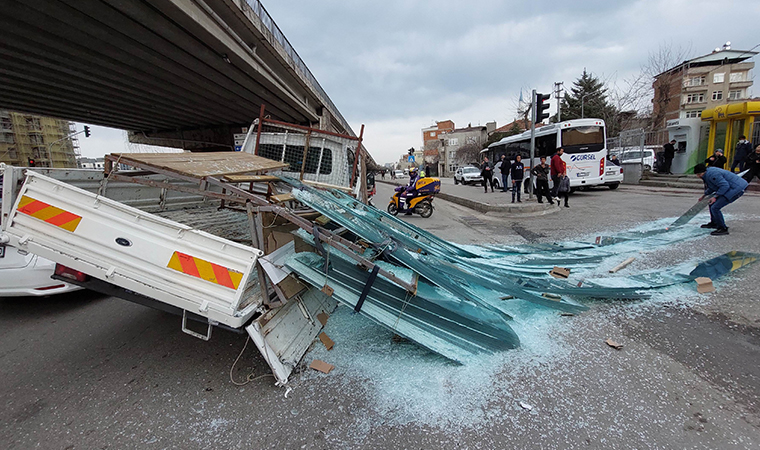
[652,46,757,128]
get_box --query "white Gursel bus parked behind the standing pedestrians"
[480,119,607,189]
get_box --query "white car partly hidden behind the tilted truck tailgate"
[0,244,82,297]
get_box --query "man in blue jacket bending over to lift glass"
[694,164,749,236]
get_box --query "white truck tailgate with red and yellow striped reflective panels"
[5,172,263,328]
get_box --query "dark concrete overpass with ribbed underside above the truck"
[0,0,354,149]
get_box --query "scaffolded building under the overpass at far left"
[0,110,79,168]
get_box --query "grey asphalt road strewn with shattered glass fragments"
[0,184,760,449]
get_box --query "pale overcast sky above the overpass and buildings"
[79,0,760,163]
